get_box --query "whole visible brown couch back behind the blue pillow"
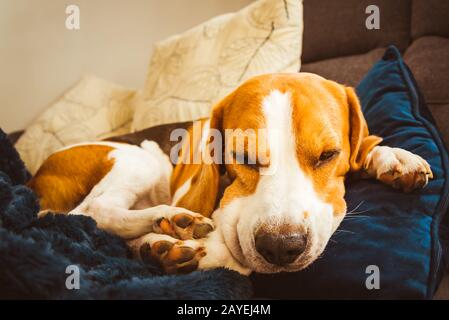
[301,0,449,148]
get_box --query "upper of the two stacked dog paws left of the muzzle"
[153,207,214,240]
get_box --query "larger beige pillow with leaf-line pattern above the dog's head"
[132,0,303,130]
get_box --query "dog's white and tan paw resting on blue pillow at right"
[365,146,433,192]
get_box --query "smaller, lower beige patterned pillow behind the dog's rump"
[16,76,137,174]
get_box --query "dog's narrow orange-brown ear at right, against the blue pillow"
[346,87,382,171]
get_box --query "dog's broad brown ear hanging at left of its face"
[171,92,230,217]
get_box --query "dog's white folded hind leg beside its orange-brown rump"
[69,141,178,238]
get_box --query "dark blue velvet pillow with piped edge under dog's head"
[252,47,449,299]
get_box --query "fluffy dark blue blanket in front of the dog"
[0,129,252,299]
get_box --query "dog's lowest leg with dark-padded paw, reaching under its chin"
[128,229,250,275]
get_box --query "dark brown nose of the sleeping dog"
[255,230,307,266]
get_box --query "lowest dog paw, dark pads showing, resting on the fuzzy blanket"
[130,234,206,274]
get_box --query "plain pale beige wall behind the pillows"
[0,0,251,132]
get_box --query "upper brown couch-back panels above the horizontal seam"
[302,0,449,63]
